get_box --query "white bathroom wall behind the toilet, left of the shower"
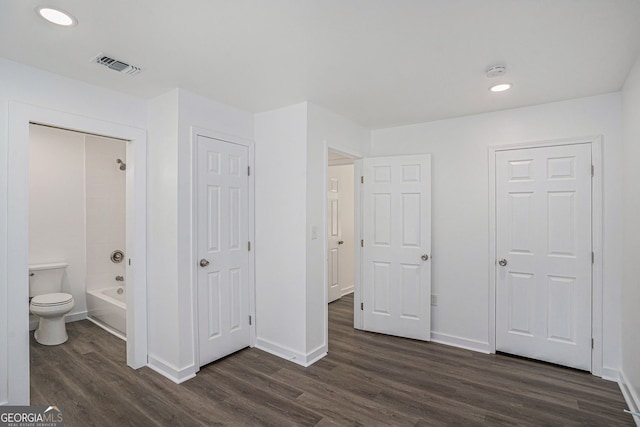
[25,125,87,318]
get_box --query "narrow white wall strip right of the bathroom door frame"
[147,90,180,375]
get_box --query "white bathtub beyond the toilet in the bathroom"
[87,286,127,339]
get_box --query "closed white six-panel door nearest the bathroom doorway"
[196,135,250,366]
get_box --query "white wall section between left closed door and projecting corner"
[254,103,307,363]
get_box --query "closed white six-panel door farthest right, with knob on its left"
[496,144,592,370]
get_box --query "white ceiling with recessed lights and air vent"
[0,0,640,128]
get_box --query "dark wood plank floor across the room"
[31,296,634,426]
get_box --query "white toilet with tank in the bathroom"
[29,262,74,345]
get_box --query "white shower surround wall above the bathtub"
[84,132,126,290]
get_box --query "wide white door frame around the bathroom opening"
[6,101,147,405]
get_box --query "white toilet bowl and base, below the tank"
[29,293,74,345]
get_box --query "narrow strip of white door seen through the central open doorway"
[327,174,342,302]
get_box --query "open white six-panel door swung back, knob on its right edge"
[357,155,431,340]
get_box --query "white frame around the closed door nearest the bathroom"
[190,126,258,372]
